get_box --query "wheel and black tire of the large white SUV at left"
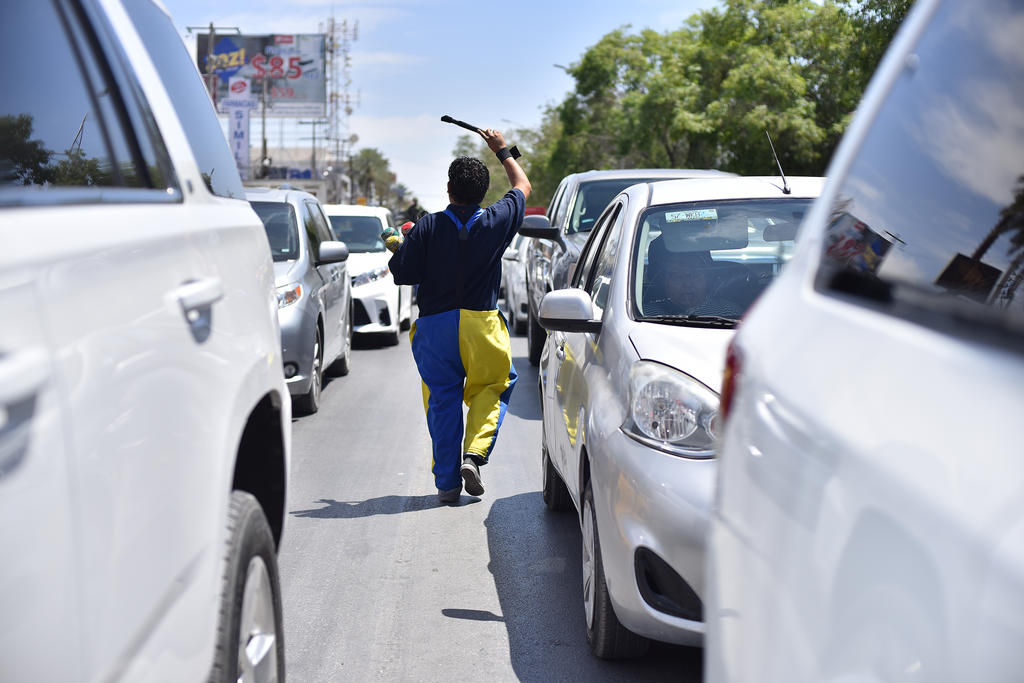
[209,490,285,683]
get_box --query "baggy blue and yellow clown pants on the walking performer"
[409,308,517,490]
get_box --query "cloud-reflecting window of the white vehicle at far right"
[816,0,1024,344]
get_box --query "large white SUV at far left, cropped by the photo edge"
[0,0,291,682]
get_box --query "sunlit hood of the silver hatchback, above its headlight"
[630,323,736,392]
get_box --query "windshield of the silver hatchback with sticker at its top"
[633,199,813,319]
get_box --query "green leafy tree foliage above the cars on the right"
[516,0,910,204]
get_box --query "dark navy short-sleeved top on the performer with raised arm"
[388,188,526,315]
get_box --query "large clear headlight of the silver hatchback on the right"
[623,360,719,458]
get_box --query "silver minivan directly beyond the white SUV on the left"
[246,185,352,415]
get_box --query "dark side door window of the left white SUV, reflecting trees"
[0,0,151,204]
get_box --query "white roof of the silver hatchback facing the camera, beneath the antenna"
[639,175,825,206]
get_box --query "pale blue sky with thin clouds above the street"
[164,0,721,211]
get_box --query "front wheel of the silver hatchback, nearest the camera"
[581,483,650,659]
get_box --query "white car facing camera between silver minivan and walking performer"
[324,204,413,345]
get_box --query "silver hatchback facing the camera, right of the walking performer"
[540,177,822,658]
